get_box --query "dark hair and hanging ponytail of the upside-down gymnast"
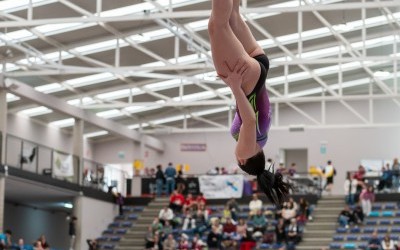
[239,151,292,206]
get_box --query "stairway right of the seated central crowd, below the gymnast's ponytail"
[296,195,345,250]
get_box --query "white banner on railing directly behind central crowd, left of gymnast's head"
[199,175,243,199]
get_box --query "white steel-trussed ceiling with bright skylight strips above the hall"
[0,0,400,140]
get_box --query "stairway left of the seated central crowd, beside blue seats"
[115,198,169,250]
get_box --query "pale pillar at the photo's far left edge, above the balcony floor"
[0,74,7,165]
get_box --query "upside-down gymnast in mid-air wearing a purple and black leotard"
[208,0,291,205]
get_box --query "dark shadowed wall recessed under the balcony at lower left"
[4,203,69,249]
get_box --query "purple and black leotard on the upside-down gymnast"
[231,54,272,148]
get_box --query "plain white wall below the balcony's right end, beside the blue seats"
[74,196,118,249]
